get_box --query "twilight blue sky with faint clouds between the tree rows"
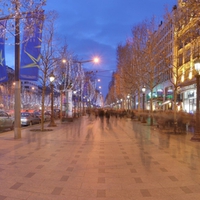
[8,0,177,97]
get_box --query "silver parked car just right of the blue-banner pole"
[21,112,41,126]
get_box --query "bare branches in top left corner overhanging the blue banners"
[0,0,46,43]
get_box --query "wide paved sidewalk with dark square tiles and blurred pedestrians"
[0,116,200,200]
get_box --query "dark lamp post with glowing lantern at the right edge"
[191,59,200,142]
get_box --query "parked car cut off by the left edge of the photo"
[0,111,14,130]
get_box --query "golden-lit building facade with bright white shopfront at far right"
[174,0,200,113]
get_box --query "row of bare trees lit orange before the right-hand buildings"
[106,0,200,133]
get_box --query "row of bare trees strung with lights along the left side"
[0,0,100,130]
